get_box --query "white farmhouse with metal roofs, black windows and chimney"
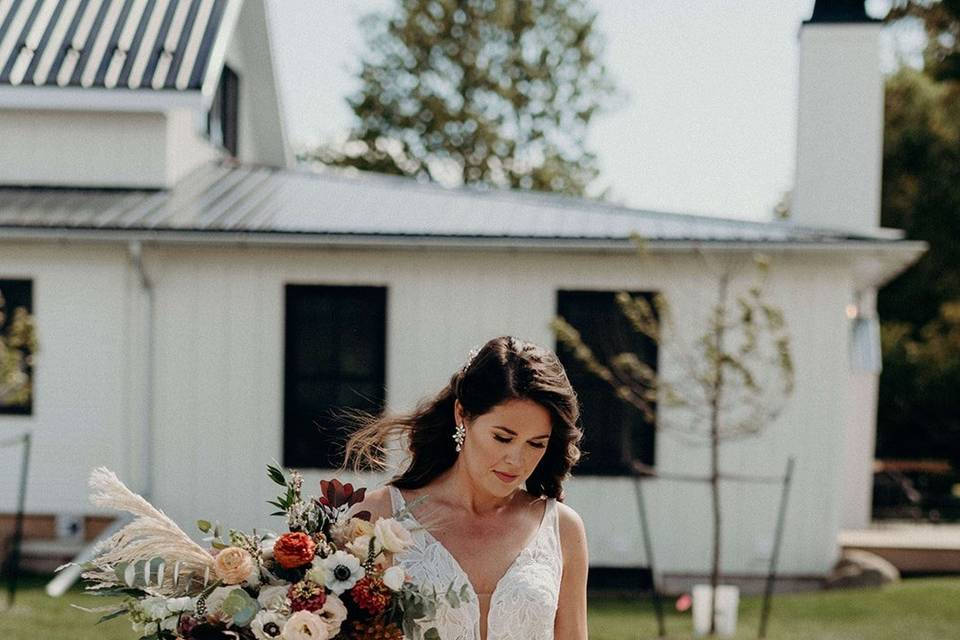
[0,0,923,588]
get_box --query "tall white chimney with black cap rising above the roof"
[791,0,884,233]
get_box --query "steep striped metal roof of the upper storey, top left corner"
[0,0,237,91]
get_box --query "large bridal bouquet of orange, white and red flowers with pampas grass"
[61,466,468,640]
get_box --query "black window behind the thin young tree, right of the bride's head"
[557,291,657,475]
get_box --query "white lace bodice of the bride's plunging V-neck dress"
[390,486,563,640]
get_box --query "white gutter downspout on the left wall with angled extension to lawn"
[46,240,155,598]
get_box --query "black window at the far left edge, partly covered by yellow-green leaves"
[0,279,36,415]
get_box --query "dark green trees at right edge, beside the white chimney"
[877,61,960,469]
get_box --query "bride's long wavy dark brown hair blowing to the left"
[344,336,583,500]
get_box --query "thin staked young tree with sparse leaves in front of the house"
[552,249,794,635]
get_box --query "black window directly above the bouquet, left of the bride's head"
[283,285,387,469]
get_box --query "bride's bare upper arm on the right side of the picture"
[553,503,589,640]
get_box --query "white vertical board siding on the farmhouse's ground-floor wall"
[0,241,850,576]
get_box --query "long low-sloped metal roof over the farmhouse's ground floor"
[0,162,916,249]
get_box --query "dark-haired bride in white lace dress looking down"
[347,337,587,640]
